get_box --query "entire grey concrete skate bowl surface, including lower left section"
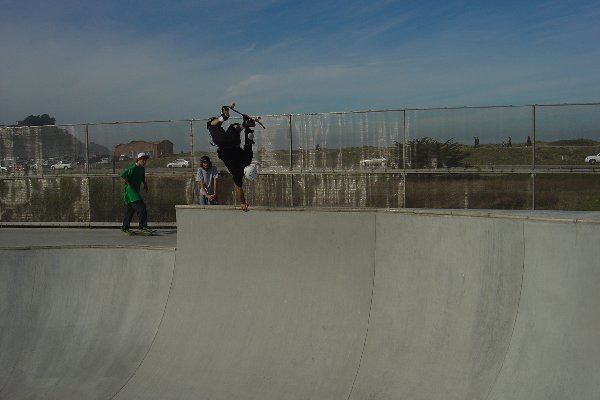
[0,206,600,400]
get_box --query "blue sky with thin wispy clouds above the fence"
[0,0,600,124]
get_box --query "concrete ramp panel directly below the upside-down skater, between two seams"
[117,208,375,400]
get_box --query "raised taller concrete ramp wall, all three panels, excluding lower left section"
[117,207,600,400]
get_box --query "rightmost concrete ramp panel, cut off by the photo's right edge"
[489,222,600,399]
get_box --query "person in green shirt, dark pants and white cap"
[119,153,154,235]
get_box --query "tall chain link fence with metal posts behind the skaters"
[0,103,600,222]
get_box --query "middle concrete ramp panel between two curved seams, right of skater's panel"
[352,213,524,400]
